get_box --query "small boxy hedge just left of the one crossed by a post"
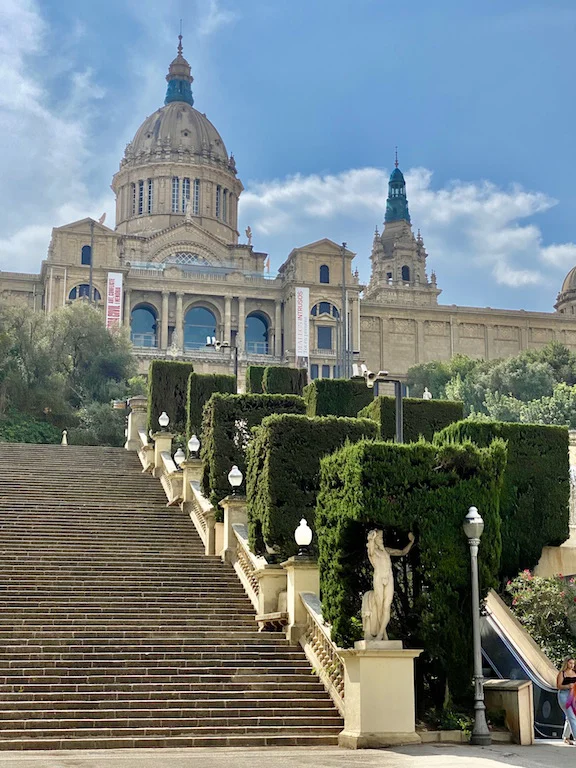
[304,379,374,417]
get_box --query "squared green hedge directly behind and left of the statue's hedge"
[246,414,377,558]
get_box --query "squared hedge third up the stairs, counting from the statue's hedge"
[200,393,306,508]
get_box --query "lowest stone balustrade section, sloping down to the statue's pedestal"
[300,592,345,717]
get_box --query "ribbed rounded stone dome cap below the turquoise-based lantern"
[130,101,229,167]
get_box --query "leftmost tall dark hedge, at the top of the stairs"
[148,360,194,434]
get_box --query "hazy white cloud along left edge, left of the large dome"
[0,0,112,271]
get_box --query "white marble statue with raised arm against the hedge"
[362,530,414,642]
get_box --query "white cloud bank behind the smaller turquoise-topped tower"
[242,168,576,288]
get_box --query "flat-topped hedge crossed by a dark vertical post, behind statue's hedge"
[358,395,464,443]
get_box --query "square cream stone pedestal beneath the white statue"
[338,640,422,749]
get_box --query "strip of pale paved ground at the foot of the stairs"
[0,741,576,768]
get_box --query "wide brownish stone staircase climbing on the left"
[0,443,342,750]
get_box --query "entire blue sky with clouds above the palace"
[0,0,576,311]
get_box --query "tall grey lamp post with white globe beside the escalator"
[463,507,492,747]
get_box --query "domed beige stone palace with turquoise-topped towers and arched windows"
[0,38,576,377]
